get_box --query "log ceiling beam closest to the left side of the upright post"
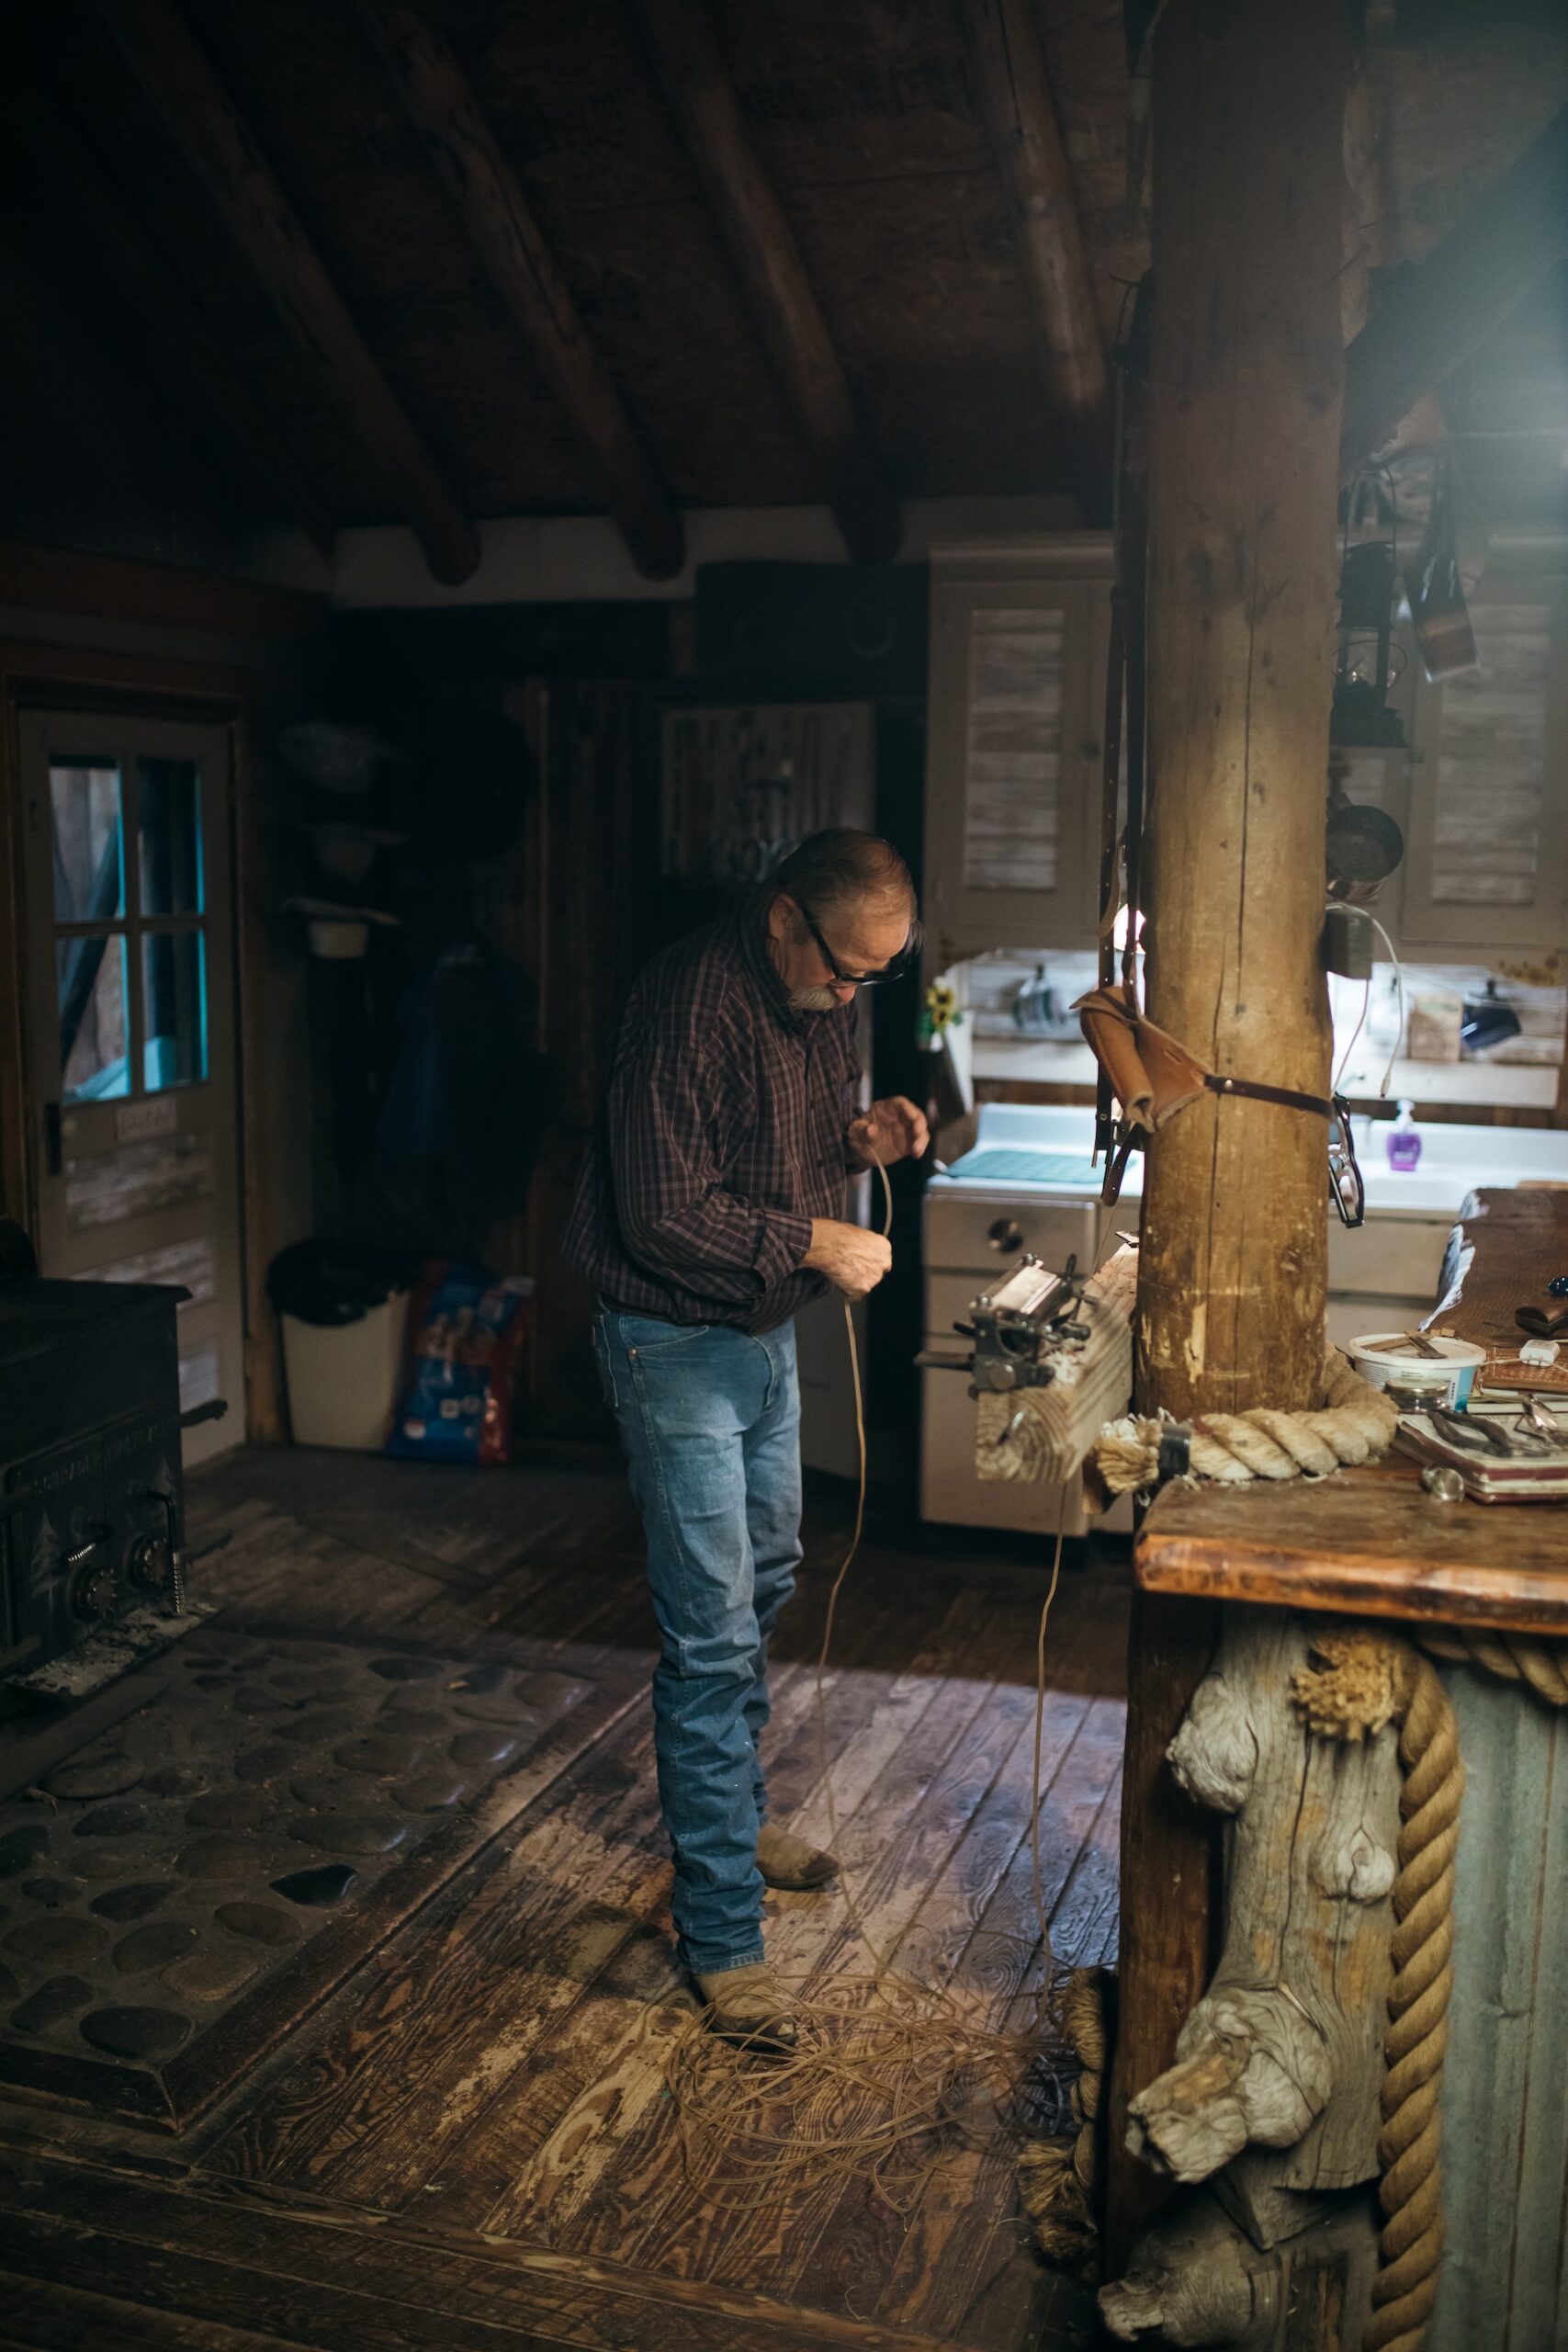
[964,0,1110,425]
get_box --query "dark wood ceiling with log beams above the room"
[0,0,1568,579]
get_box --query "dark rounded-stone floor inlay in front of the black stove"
[0,1628,588,2124]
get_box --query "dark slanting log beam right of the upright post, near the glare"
[1340,106,1568,484]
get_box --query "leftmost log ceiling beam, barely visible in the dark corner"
[0,54,336,558]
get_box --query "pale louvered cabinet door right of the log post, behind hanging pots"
[1401,579,1568,962]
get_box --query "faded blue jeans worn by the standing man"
[592,1310,799,1975]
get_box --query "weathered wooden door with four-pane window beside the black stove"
[21,710,244,1465]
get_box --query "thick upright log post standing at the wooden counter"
[1110,0,1345,2258]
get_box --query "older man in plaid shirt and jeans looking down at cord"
[564,831,926,2049]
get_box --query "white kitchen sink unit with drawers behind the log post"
[919,1103,1568,1536]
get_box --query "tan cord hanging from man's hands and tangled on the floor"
[665,1162,1077,2213]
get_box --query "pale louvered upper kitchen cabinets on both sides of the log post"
[924,532,1568,971]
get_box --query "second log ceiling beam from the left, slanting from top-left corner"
[98,0,479,583]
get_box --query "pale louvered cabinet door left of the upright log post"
[926,579,1107,965]
